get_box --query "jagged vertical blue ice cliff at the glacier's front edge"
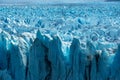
[0,31,119,80]
